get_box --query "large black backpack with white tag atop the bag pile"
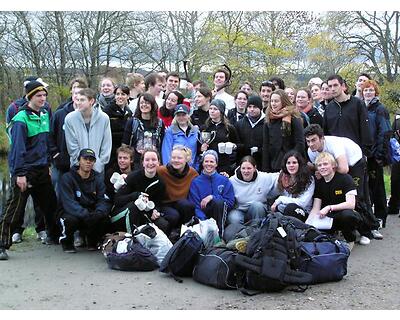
[235,213,312,295]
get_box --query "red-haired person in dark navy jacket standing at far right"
[361,80,392,230]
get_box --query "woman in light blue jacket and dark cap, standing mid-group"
[161,104,199,170]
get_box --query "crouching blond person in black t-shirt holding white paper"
[306,152,361,250]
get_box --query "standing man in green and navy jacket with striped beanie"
[0,81,58,260]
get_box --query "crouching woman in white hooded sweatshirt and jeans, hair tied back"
[228,156,279,224]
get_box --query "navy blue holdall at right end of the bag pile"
[299,234,350,283]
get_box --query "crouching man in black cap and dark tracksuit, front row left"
[60,149,111,253]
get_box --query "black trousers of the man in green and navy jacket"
[0,167,60,249]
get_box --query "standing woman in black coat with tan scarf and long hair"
[262,89,305,172]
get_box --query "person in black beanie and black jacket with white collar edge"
[235,95,265,168]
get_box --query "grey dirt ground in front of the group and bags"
[0,216,400,310]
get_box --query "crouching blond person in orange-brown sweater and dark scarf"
[157,145,199,228]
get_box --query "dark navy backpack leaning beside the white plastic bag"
[160,230,204,282]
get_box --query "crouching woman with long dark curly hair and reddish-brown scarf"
[271,150,315,222]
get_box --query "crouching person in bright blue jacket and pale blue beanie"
[188,150,235,237]
